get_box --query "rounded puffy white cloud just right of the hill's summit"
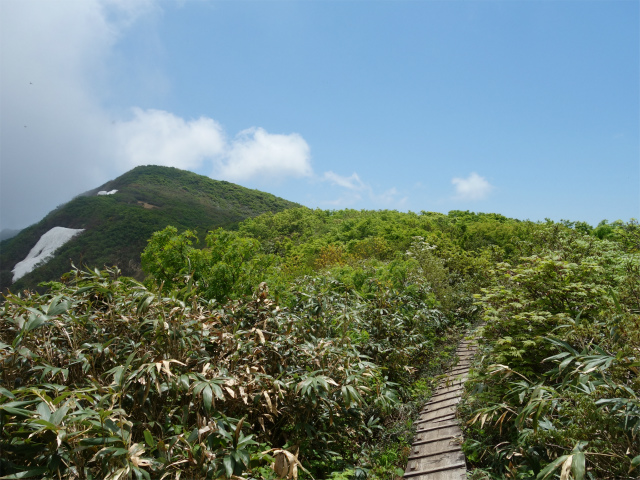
[214,128,313,181]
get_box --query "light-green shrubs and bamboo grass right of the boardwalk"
[463,224,640,480]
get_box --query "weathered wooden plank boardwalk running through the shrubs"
[404,340,477,480]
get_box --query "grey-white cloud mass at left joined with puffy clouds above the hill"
[0,0,313,229]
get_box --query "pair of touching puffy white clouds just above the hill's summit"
[116,108,313,181]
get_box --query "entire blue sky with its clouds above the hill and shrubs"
[0,0,640,228]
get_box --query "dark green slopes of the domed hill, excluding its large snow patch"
[0,166,300,292]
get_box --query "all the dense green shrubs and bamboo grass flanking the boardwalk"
[0,208,640,479]
